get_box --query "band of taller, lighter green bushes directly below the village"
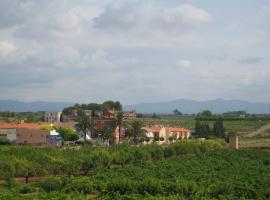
[0,140,224,177]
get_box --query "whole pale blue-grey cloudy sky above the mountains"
[0,0,270,104]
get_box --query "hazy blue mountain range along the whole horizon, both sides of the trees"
[0,99,270,114]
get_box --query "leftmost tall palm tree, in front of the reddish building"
[75,110,94,141]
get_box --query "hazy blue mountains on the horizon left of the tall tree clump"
[0,100,74,112]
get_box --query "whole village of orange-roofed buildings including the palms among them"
[0,106,191,147]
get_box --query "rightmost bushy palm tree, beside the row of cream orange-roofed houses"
[127,120,146,144]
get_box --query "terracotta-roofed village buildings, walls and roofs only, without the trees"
[0,110,191,146]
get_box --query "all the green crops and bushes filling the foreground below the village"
[0,141,270,200]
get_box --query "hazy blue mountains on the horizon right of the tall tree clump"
[124,99,270,114]
